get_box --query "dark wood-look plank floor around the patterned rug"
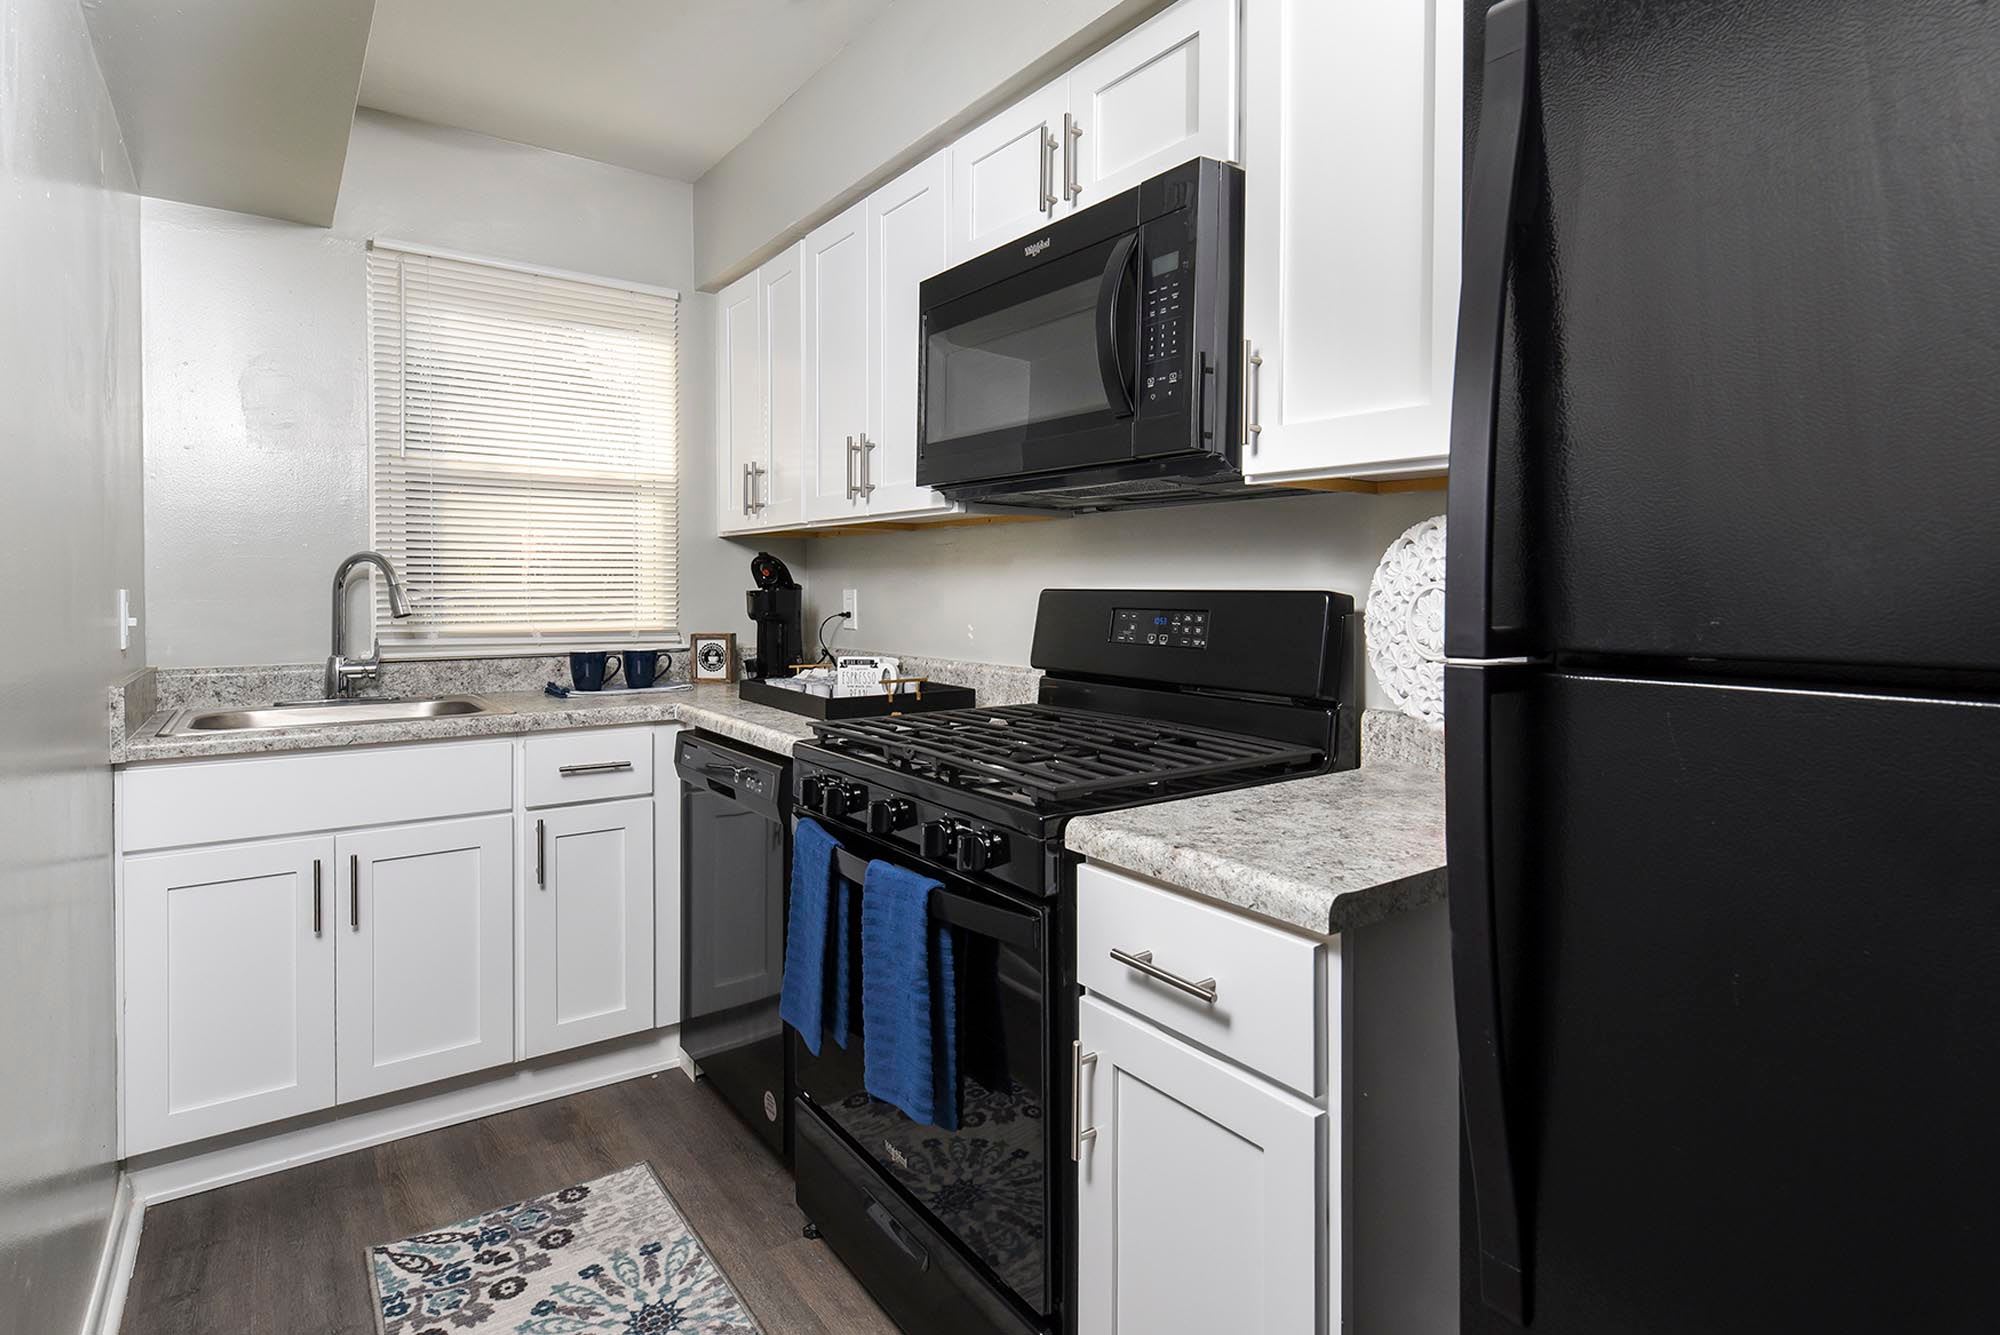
[122,1071,896,1335]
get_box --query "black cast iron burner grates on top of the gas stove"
[814,705,1322,803]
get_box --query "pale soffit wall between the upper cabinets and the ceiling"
[694,0,1168,290]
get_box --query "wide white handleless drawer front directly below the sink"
[120,741,514,851]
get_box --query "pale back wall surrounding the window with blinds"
[142,110,768,666]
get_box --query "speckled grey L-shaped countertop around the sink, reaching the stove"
[112,685,812,765]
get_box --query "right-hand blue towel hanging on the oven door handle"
[862,861,958,1131]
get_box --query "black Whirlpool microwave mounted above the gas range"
[916,158,1262,510]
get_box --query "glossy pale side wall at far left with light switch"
[0,0,144,1333]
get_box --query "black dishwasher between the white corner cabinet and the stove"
[674,731,794,1161]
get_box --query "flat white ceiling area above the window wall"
[360,0,890,180]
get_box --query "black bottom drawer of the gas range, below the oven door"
[792,1099,1042,1335]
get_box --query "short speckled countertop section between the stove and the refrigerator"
[1064,751,1444,935]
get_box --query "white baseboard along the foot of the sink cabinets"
[126,1025,686,1207]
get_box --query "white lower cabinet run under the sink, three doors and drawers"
[116,723,680,1155]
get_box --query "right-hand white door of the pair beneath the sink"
[332,815,514,1103]
